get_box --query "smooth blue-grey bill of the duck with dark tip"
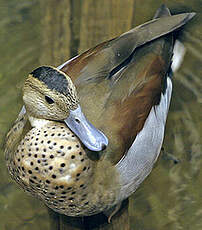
[64,106,108,151]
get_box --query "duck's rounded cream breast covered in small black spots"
[6,119,120,216]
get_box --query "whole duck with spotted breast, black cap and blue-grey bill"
[5,5,195,217]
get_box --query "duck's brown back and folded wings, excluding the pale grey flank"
[60,6,194,164]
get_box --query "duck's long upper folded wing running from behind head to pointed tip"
[58,13,195,85]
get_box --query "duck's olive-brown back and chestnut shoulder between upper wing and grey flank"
[60,33,172,164]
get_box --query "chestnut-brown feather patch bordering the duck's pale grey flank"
[98,55,165,163]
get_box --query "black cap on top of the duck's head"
[30,66,68,95]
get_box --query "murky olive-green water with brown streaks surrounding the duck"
[0,0,202,230]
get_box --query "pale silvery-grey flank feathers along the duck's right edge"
[116,77,172,200]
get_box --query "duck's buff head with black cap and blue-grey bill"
[23,66,108,151]
